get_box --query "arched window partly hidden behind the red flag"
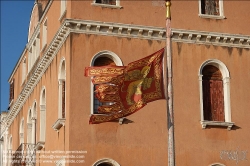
[91,51,123,114]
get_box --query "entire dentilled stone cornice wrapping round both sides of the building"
[0,19,250,137]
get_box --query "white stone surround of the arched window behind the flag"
[90,50,123,114]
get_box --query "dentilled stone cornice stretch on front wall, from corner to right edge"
[66,19,250,49]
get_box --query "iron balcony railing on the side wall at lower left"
[12,143,36,166]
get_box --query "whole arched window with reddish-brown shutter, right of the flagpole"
[199,59,234,130]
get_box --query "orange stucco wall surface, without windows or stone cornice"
[4,1,250,166]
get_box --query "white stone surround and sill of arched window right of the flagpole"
[198,59,234,130]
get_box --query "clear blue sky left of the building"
[0,0,35,111]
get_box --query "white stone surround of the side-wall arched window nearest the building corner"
[52,57,67,131]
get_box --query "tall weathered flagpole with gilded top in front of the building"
[166,0,175,166]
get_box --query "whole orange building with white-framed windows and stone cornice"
[1,0,250,166]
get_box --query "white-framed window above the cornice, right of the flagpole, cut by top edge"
[199,0,225,19]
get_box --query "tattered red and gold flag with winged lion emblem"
[85,48,165,124]
